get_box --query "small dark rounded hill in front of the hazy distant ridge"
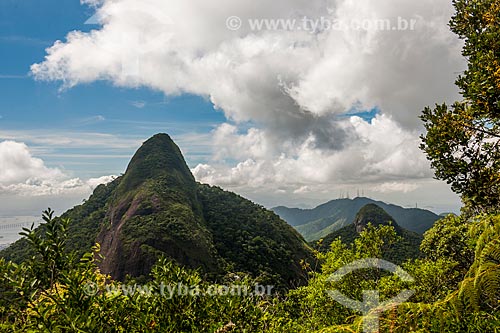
[318,204,423,263]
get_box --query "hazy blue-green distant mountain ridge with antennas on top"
[272,197,440,241]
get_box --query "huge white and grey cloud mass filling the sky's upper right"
[31,0,465,202]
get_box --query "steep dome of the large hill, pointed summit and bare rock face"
[97,134,220,279]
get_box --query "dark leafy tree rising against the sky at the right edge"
[421,0,500,213]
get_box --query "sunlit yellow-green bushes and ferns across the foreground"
[0,211,500,332]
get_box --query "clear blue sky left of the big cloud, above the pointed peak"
[0,0,225,177]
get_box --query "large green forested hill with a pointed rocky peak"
[0,134,312,285]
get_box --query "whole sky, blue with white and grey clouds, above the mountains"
[0,0,466,216]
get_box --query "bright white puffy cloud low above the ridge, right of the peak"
[193,115,432,187]
